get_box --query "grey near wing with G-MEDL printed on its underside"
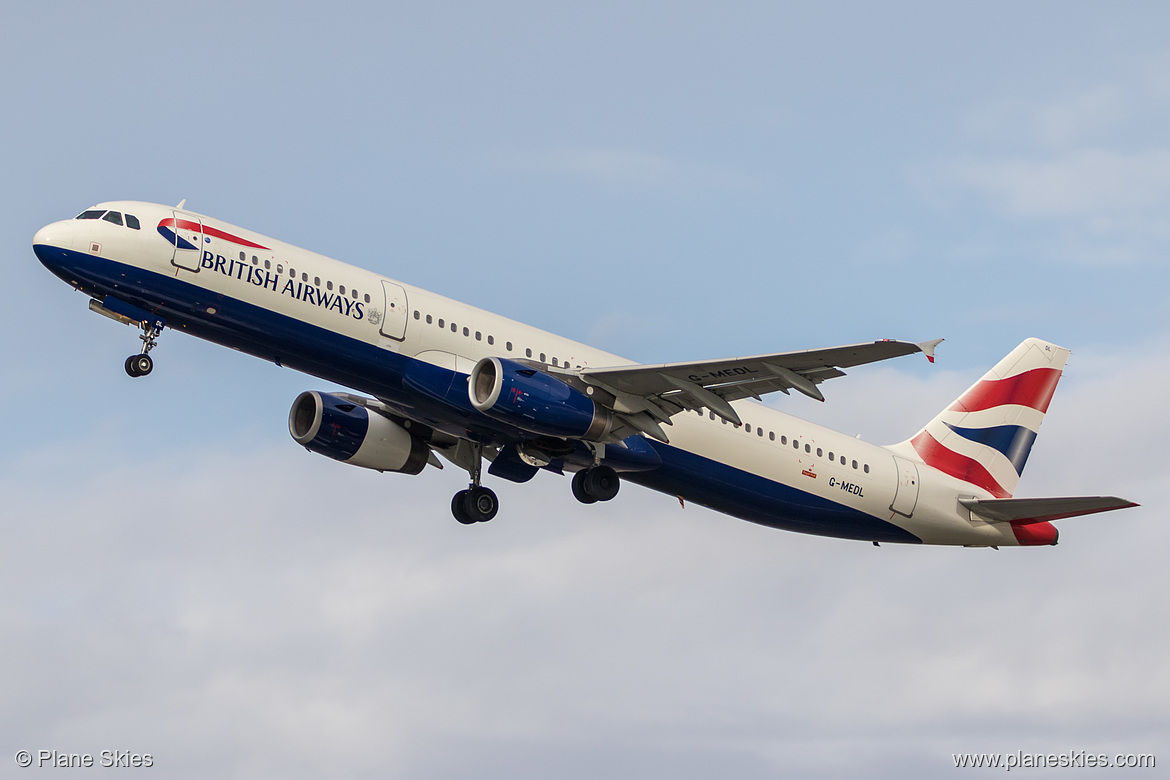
[572,339,942,441]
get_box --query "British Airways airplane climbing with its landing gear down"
[33,201,1137,548]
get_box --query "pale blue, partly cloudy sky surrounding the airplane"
[0,1,1170,780]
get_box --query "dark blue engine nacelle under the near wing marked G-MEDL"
[467,358,614,441]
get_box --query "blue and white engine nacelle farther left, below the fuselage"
[289,391,431,474]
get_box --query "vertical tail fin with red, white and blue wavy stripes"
[894,338,1068,498]
